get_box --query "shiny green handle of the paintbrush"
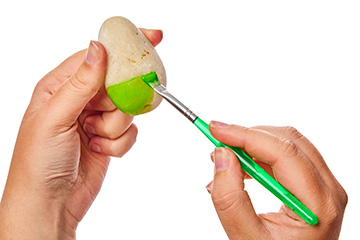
[193,118,318,225]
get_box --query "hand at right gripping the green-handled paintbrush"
[207,121,348,240]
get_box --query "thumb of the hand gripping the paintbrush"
[211,148,266,239]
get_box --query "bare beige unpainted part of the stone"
[99,17,166,115]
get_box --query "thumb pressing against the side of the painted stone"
[48,41,107,126]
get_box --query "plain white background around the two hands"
[0,0,360,239]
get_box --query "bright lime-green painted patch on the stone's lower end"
[106,76,154,116]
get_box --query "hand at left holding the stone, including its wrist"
[0,29,162,240]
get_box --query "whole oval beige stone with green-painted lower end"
[99,17,166,115]
